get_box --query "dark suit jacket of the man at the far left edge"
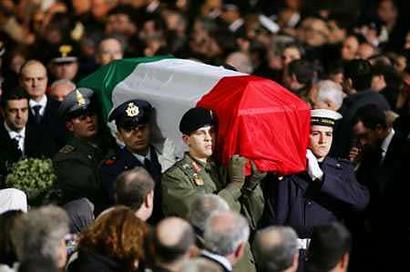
[0,120,48,187]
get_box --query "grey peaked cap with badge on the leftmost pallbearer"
[59,88,94,119]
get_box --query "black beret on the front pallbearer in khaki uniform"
[179,107,214,135]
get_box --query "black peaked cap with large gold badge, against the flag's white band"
[108,99,152,129]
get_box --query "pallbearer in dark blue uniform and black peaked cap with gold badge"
[100,99,175,222]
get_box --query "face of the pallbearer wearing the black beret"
[183,126,215,162]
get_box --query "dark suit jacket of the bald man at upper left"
[28,96,68,157]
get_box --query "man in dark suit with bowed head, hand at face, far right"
[350,105,410,270]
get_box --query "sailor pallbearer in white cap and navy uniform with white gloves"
[275,109,369,249]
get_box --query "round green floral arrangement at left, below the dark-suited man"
[6,158,57,202]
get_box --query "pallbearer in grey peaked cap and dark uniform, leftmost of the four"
[53,88,114,213]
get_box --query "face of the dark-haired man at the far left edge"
[3,99,28,131]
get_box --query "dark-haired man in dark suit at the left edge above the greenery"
[0,88,47,186]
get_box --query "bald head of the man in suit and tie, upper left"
[20,60,48,101]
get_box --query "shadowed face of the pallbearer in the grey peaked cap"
[67,112,98,139]
